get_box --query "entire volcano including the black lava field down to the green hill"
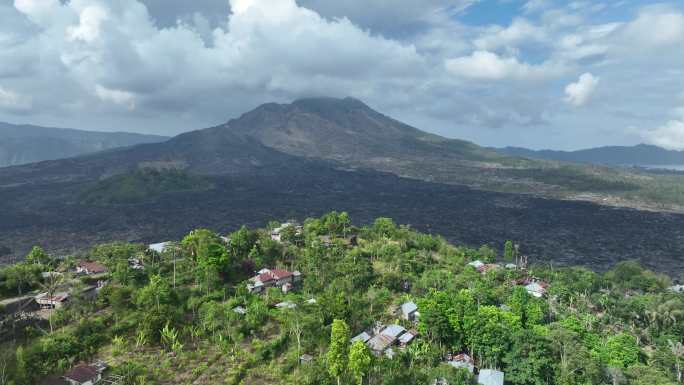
[0,98,684,273]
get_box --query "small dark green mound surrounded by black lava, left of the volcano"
[80,169,211,205]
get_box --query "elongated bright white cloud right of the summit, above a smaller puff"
[445,51,560,80]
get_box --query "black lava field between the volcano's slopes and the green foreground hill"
[0,166,684,277]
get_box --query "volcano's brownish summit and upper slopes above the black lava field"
[0,98,684,210]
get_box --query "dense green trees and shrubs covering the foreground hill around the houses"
[0,213,684,385]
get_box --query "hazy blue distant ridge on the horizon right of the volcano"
[497,144,684,166]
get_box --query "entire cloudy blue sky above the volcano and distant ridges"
[0,0,684,149]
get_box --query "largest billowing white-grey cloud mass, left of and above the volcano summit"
[9,0,424,124]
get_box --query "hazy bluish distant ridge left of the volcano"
[0,122,168,167]
